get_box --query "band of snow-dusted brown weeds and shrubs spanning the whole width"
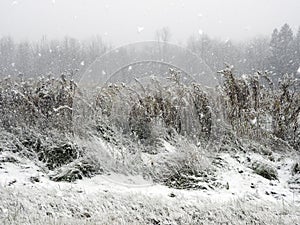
[0,65,300,185]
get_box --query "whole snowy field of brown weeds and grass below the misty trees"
[0,66,300,224]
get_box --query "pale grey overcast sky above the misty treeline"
[0,0,300,45]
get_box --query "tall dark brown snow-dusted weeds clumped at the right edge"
[219,66,300,149]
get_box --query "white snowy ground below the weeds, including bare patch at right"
[0,146,300,224]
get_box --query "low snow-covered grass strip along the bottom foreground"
[0,164,300,224]
